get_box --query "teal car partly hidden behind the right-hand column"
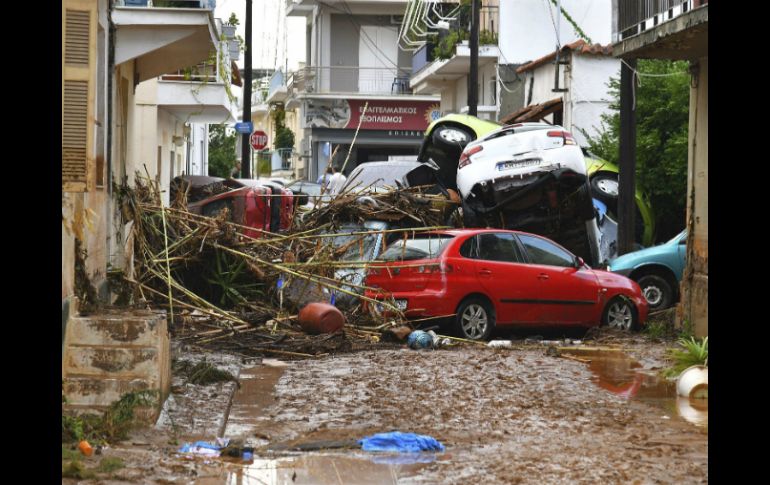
[607,230,687,311]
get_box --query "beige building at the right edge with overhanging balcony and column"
[613,0,708,337]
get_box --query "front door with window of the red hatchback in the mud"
[518,234,599,324]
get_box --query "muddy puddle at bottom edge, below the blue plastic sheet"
[225,453,428,485]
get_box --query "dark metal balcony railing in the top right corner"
[612,0,708,42]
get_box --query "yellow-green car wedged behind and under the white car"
[417,114,655,246]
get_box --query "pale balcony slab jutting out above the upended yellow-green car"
[409,44,500,94]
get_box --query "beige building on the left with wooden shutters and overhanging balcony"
[62,0,237,329]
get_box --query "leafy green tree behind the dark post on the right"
[584,59,690,241]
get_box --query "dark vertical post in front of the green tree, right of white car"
[618,59,636,255]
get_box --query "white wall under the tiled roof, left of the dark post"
[565,55,620,146]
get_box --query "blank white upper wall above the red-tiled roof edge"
[499,0,612,64]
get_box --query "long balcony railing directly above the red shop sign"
[287,66,412,94]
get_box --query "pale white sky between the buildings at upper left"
[214,0,305,71]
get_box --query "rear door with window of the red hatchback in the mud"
[460,232,539,324]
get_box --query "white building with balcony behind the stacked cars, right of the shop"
[407,0,612,120]
